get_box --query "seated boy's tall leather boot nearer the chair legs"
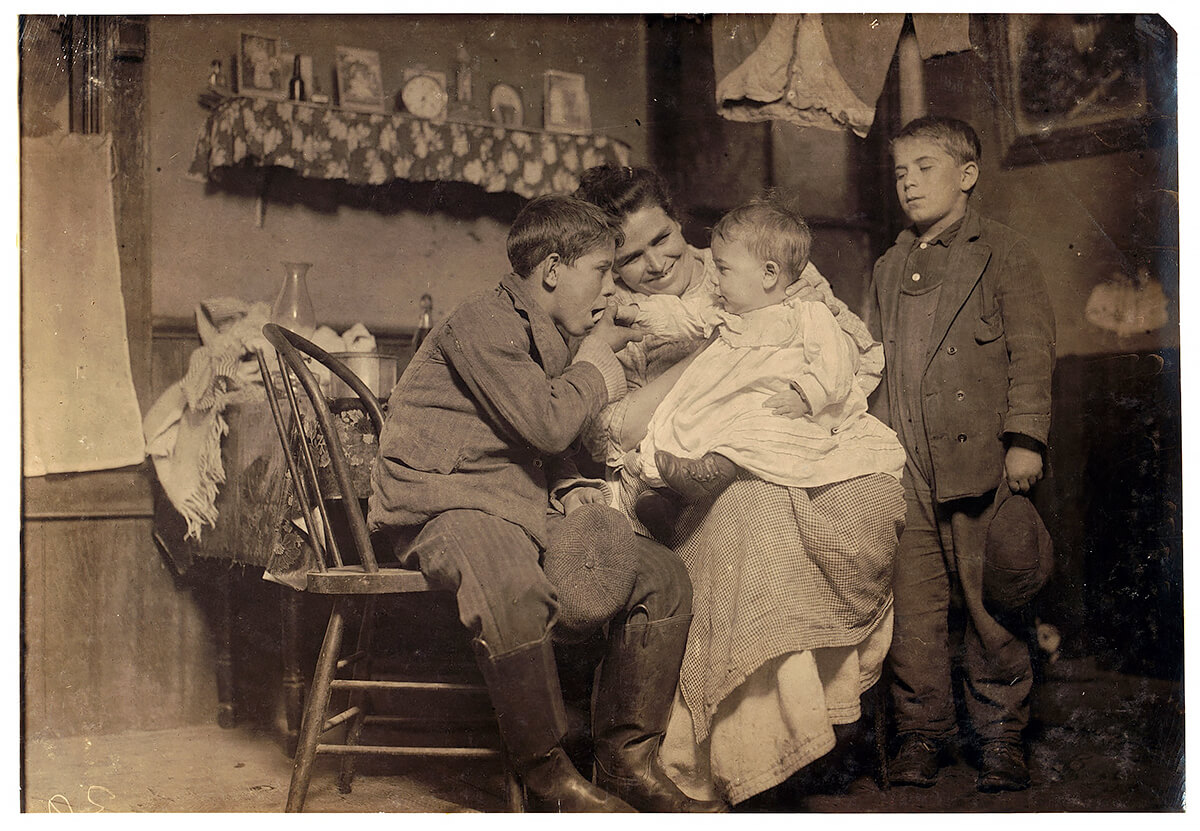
[474,635,634,813]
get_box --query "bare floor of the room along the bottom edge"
[23,659,1183,813]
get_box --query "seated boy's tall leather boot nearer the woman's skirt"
[592,605,726,813]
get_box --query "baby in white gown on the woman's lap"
[618,201,905,540]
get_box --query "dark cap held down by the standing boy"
[983,484,1054,611]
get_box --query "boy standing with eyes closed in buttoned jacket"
[871,116,1055,791]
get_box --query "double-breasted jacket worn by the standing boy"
[870,207,1055,502]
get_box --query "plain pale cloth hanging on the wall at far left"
[20,133,145,476]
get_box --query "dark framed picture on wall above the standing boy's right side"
[996,14,1156,167]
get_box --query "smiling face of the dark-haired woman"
[613,205,691,297]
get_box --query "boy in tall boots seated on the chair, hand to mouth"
[368,196,722,812]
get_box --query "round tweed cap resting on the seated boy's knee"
[542,504,638,640]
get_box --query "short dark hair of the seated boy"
[508,195,623,277]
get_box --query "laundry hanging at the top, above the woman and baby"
[713,14,971,137]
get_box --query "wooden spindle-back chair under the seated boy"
[258,323,522,812]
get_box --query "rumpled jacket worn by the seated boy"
[368,268,624,548]
